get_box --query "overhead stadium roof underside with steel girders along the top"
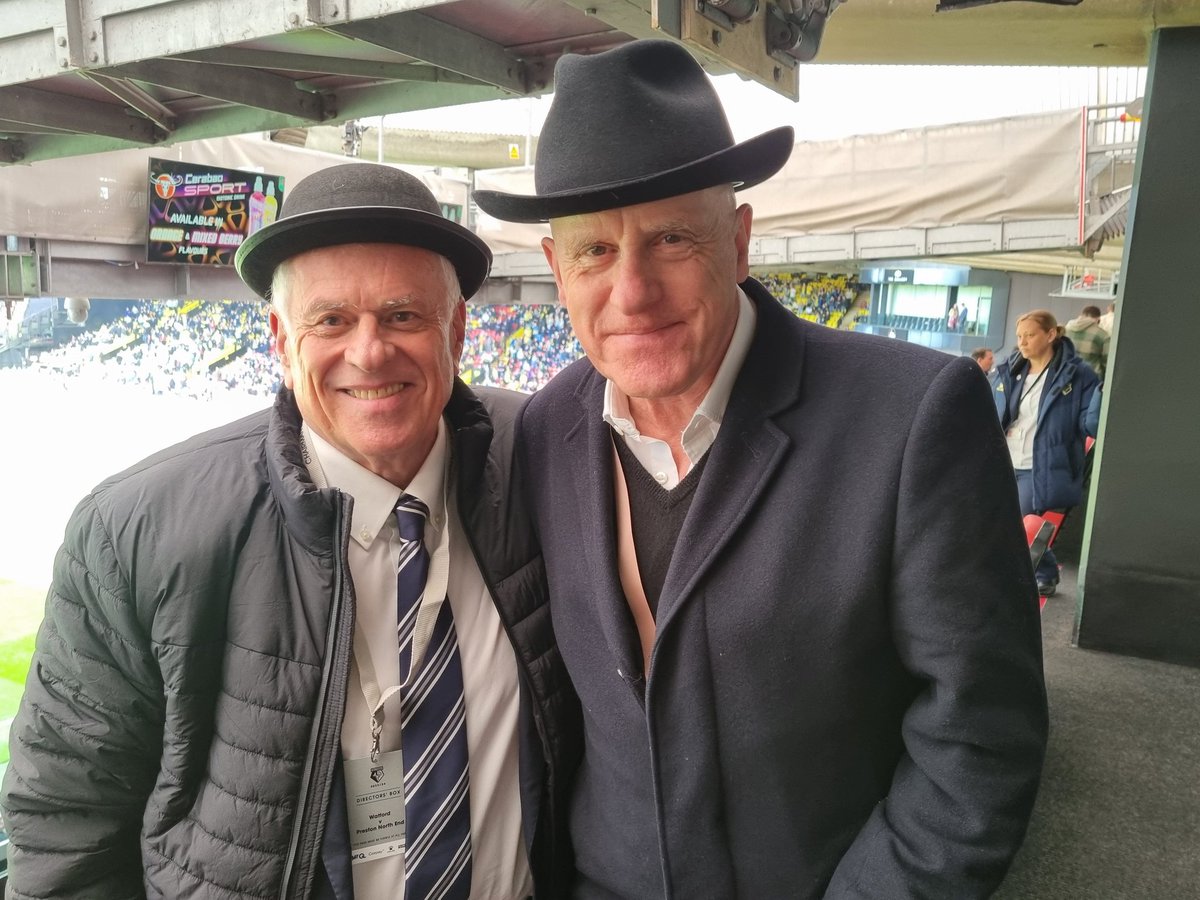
[0,0,1200,164]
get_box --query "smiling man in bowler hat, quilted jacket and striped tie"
[2,164,578,900]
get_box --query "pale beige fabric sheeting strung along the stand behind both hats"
[0,110,1081,253]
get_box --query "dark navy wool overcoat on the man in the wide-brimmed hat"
[520,280,1048,900]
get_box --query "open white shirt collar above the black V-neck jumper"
[604,288,757,491]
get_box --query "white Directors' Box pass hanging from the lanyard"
[342,750,404,865]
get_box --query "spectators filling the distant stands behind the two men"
[0,272,858,400]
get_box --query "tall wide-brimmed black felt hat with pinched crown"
[474,41,796,222]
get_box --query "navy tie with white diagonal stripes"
[396,493,470,900]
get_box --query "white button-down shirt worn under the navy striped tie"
[304,421,533,900]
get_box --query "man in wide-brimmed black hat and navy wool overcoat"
[475,41,1046,900]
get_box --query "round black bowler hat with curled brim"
[234,163,492,298]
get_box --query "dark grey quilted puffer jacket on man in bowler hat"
[0,384,578,900]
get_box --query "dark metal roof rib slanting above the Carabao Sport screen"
[104,59,331,121]
